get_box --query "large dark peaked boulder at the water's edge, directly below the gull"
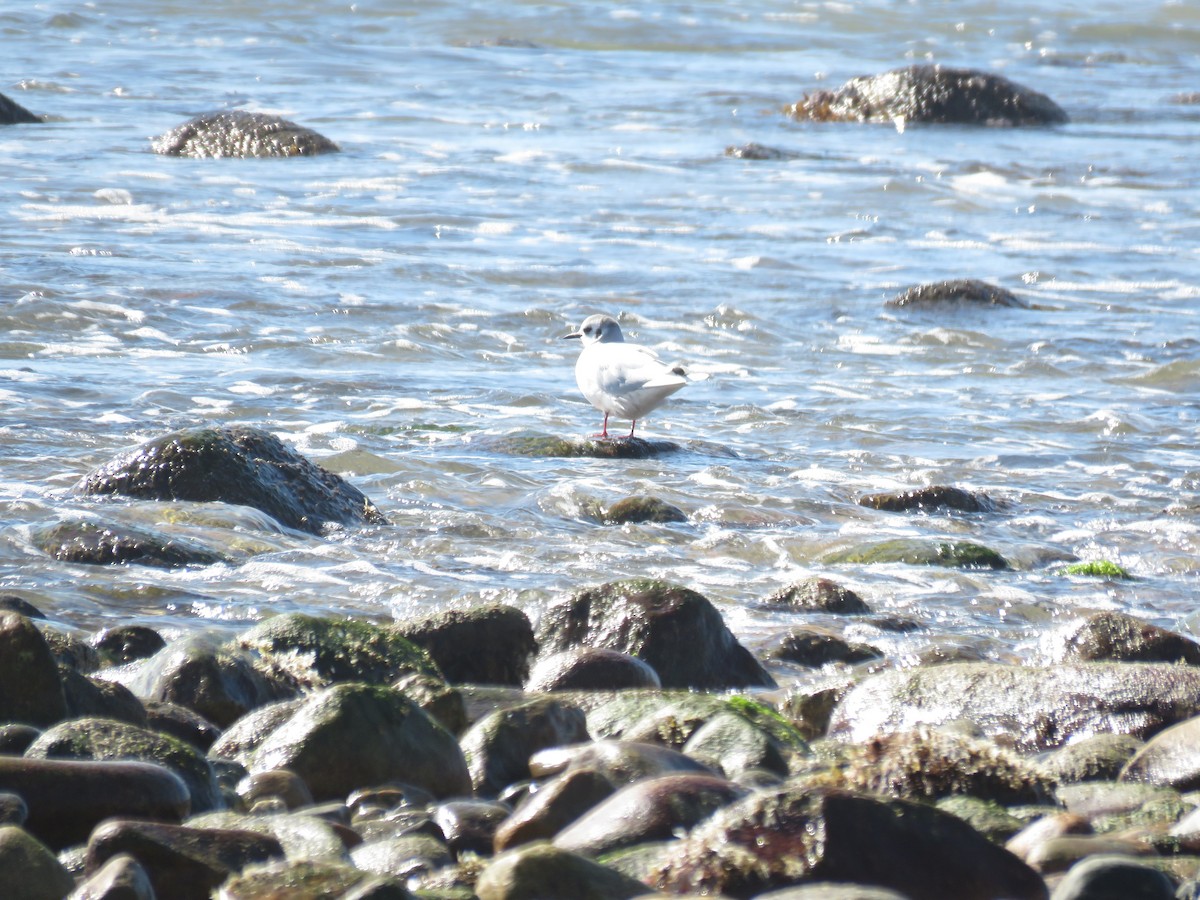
[538,580,775,690]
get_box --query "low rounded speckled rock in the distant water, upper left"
[151,109,338,160]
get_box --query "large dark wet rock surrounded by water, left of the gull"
[76,425,386,534]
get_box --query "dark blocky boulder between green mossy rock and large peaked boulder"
[395,604,538,688]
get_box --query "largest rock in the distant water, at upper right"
[787,65,1067,126]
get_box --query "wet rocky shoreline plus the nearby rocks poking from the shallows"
[0,426,1200,900]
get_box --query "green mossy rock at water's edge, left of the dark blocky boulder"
[238,612,442,686]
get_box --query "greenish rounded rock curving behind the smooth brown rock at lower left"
[25,718,222,812]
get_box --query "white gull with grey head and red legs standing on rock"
[563,316,688,438]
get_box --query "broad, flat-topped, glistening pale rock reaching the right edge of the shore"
[829,662,1200,752]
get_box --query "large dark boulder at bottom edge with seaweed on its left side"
[652,786,1046,900]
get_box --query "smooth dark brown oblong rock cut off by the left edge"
[0,756,191,850]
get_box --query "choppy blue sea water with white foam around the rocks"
[0,0,1200,691]
